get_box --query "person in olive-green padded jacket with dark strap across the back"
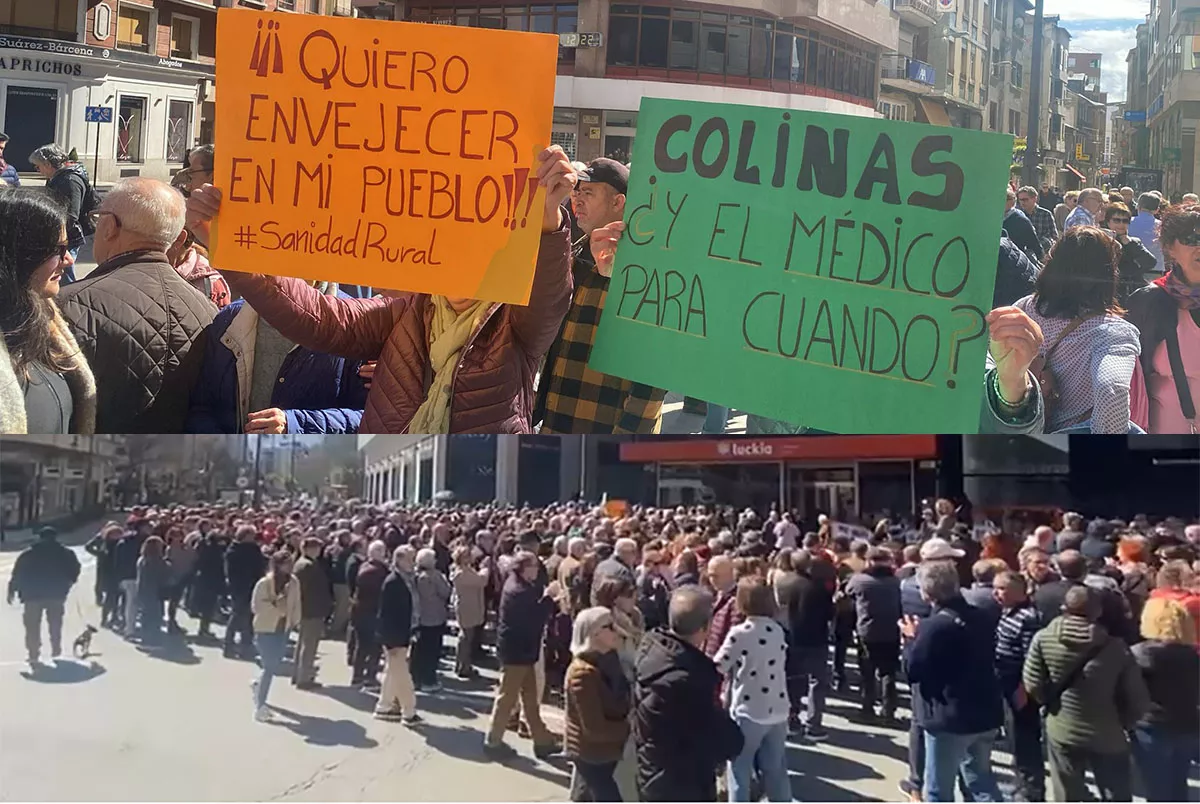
[1024,586,1150,802]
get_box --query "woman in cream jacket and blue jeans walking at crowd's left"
[251,550,301,722]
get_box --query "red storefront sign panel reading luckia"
[620,436,937,463]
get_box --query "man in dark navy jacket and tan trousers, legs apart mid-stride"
[484,551,558,758]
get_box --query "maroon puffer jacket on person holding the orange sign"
[223,227,572,433]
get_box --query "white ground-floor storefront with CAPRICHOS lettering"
[0,36,214,184]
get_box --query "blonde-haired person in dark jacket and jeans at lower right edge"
[1132,598,1200,802]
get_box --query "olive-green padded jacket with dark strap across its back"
[1024,614,1150,754]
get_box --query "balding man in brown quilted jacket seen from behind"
[59,178,217,433]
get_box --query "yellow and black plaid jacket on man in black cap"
[534,241,666,436]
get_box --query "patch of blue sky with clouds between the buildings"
[1045,0,1150,101]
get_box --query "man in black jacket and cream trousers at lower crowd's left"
[374,545,422,726]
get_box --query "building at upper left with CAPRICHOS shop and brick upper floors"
[0,0,352,184]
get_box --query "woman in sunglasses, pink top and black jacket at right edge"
[1128,204,1200,436]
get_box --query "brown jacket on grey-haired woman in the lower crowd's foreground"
[563,650,632,763]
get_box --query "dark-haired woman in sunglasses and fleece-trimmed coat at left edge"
[0,188,96,433]
